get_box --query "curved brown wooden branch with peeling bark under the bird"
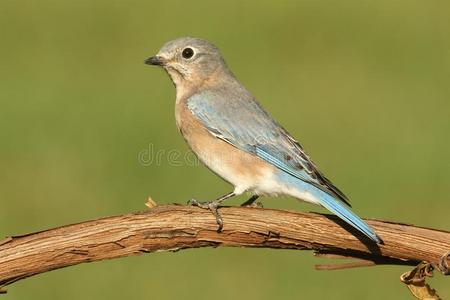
[0,205,450,287]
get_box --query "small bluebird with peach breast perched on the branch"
[145,37,383,244]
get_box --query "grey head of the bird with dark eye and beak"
[145,37,229,87]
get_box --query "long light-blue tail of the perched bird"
[280,174,383,244]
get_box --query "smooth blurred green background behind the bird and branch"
[0,0,450,299]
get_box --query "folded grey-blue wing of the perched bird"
[187,90,349,204]
